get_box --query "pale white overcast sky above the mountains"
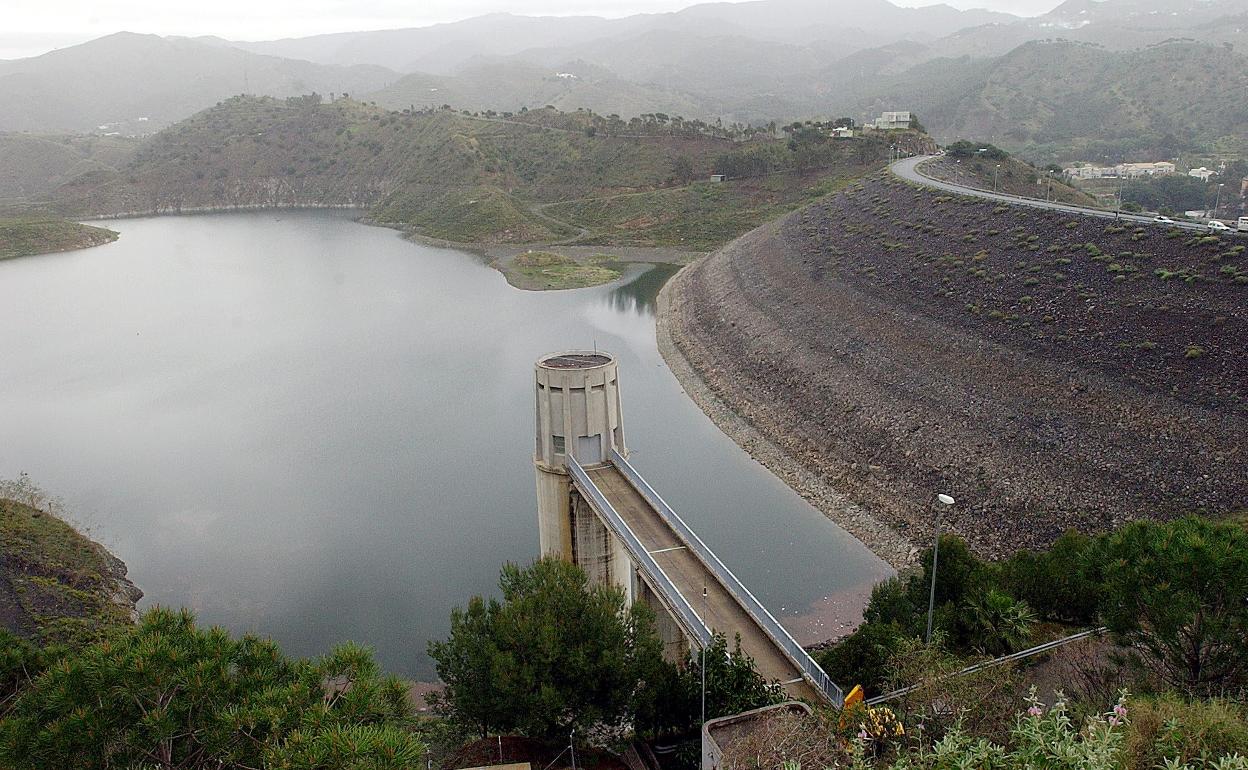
[0,0,1058,59]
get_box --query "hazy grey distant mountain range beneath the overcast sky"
[0,0,1248,155]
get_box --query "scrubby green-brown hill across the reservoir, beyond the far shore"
[56,96,886,248]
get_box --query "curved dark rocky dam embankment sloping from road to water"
[660,175,1248,564]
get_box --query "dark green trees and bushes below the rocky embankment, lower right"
[820,517,1248,696]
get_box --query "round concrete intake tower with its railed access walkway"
[533,351,844,706]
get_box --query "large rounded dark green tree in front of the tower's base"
[429,558,663,738]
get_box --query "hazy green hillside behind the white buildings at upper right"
[860,41,1248,160]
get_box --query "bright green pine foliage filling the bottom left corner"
[0,609,424,770]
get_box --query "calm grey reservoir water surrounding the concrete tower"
[0,212,889,679]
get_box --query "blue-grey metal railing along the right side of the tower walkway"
[606,449,845,708]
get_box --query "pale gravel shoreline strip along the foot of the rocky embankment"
[654,252,919,570]
